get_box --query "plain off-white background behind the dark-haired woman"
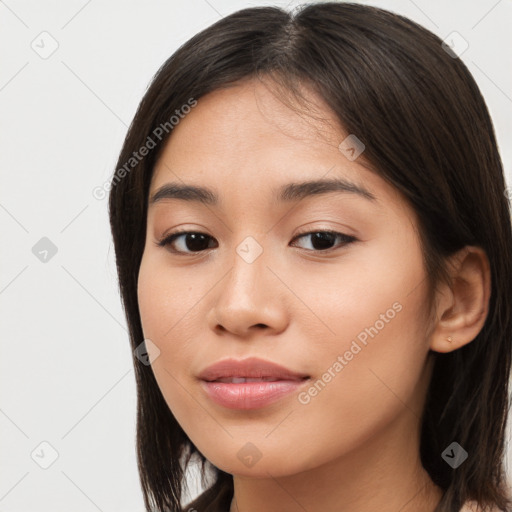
[0,0,512,512]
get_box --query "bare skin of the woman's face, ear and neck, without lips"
[138,80,490,512]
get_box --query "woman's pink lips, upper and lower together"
[198,357,309,409]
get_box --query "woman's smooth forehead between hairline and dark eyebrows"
[150,79,408,217]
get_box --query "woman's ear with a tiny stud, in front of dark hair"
[430,246,491,352]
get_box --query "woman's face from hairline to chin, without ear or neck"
[138,80,436,477]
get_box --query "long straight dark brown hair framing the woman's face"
[109,2,512,512]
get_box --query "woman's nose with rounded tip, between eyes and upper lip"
[208,241,289,338]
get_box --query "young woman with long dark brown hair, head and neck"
[109,3,512,512]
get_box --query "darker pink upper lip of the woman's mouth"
[199,357,309,382]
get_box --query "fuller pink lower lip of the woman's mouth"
[201,379,309,409]
